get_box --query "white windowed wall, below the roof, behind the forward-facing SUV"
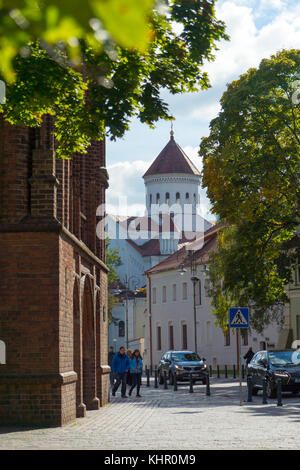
[145,270,279,366]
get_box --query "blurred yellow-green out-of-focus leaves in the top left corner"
[0,0,154,81]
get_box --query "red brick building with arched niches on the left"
[0,117,110,426]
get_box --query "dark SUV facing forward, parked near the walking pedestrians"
[158,351,207,384]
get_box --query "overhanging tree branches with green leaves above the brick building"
[0,0,228,158]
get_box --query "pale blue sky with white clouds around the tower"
[106,0,300,219]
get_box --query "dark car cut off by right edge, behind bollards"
[248,349,300,398]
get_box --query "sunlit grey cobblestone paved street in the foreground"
[0,379,300,450]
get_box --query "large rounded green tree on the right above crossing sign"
[200,50,300,331]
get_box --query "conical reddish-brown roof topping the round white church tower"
[143,135,200,178]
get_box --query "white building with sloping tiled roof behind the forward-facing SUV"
[145,228,279,369]
